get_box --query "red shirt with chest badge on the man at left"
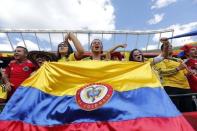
[5,60,35,90]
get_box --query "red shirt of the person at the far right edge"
[186,59,197,92]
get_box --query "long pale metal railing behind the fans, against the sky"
[0,29,174,51]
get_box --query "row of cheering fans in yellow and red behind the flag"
[0,33,197,112]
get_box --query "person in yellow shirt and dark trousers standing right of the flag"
[154,38,192,112]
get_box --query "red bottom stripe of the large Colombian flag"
[0,116,194,131]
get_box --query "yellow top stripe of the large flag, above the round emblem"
[22,61,161,96]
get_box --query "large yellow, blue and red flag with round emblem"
[0,61,193,131]
